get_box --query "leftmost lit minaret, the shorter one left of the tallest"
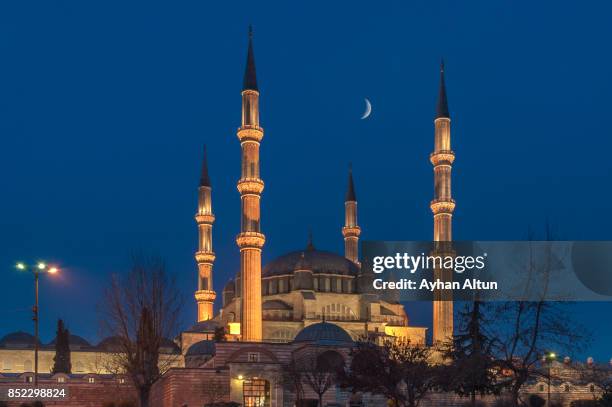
[195,147,217,322]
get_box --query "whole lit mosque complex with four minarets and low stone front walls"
[0,32,455,407]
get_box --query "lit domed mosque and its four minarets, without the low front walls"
[183,27,455,350]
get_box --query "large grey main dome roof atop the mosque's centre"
[261,248,359,277]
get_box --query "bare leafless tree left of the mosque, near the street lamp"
[101,256,182,407]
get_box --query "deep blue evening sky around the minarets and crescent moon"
[0,1,612,360]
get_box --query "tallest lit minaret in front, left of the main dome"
[236,27,265,342]
